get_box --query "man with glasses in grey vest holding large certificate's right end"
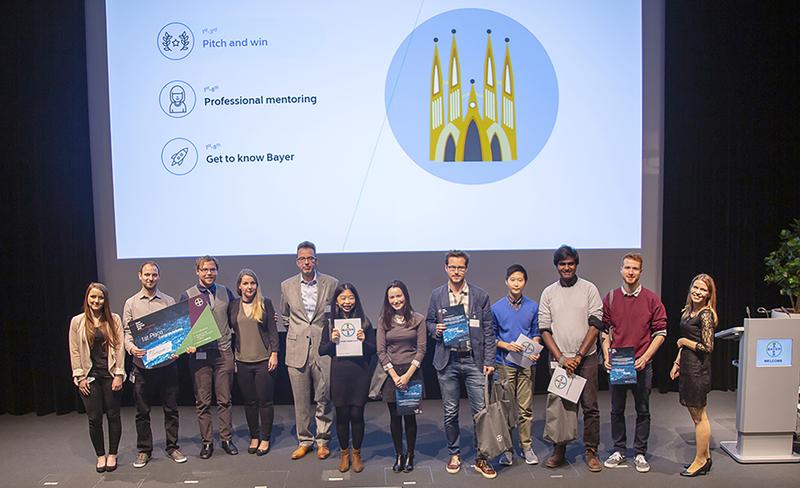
[180,256,234,459]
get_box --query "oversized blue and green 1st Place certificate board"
[128,295,222,368]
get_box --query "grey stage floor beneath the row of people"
[0,392,800,488]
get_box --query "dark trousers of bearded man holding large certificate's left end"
[131,362,178,454]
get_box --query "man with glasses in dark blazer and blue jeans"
[425,250,497,479]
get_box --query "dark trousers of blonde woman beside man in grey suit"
[236,360,275,441]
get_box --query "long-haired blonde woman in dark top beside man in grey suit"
[228,268,278,456]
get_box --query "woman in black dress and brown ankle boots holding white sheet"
[319,283,375,473]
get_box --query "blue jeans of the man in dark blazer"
[436,353,486,459]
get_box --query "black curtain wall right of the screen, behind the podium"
[656,0,800,389]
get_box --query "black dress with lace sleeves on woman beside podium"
[678,309,715,407]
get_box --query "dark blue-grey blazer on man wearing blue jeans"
[425,283,497,371]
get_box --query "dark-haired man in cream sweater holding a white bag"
[539,245,603,473]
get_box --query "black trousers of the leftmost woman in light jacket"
[81,378,122,456]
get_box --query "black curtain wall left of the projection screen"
[0,0,97,414]
